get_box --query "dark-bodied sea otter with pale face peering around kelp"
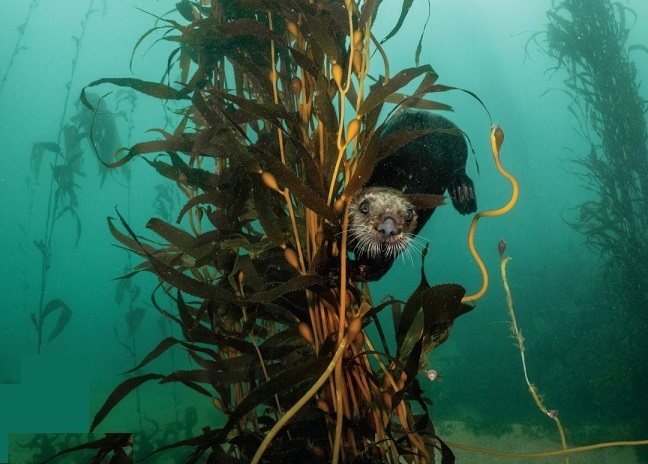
[348,110,477,282]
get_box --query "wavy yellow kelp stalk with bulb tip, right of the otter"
[461,125,520,303]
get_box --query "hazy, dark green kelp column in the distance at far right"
[542,0,648,438]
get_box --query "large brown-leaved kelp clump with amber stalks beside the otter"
[82,1,470,462]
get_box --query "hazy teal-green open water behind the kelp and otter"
[0,0,648,463]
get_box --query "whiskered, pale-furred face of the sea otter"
[349,187,417,258]
